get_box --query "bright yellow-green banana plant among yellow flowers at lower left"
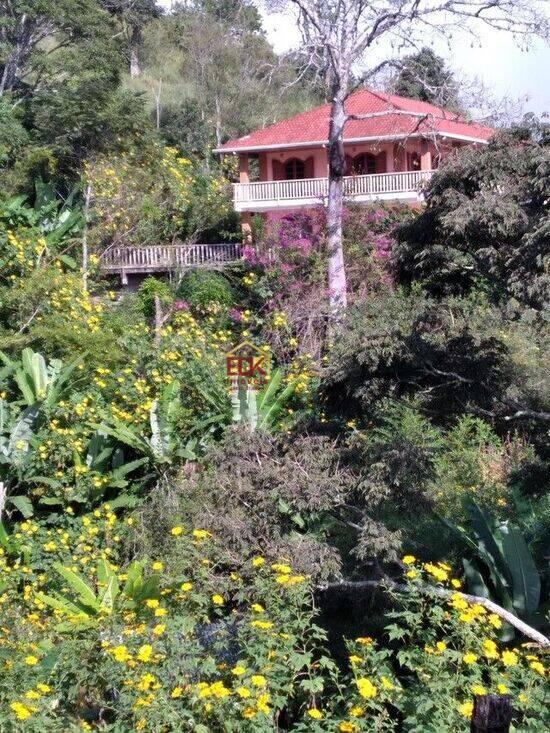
[36,559,160,631]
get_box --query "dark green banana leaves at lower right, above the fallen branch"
[446,502,540,618]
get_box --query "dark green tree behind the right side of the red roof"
[388,46,460,110]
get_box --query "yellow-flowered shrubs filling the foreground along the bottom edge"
[0,516,548,733]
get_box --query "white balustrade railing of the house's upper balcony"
[233,170,433,212]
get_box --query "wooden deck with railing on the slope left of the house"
[100,243,241,285]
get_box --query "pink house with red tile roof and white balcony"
[216,89,494,233]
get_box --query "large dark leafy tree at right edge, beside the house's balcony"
[393,129,550,309]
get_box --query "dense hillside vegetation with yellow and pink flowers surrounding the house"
[0,0,550,733]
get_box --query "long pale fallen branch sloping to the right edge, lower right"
[317,577,550,647]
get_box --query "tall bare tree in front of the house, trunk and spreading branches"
[272,0,550,318]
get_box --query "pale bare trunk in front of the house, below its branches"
[327,79,347,318]
